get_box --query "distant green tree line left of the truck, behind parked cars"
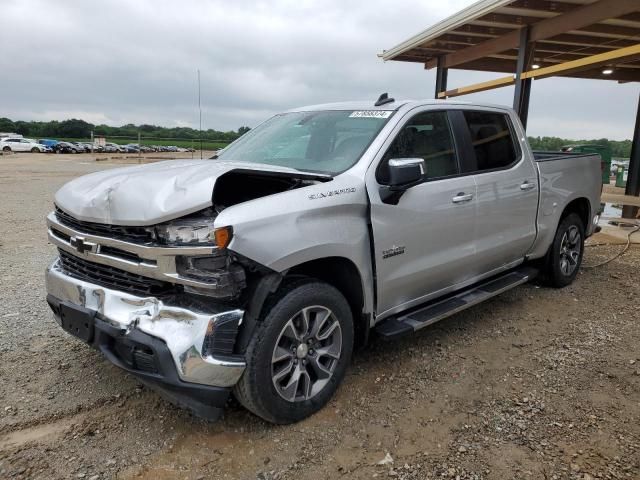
[0,118,249,142]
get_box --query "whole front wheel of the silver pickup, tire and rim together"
[234,280,353,424]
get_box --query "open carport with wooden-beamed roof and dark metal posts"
[380,0,640,216]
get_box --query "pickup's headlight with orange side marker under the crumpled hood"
[156,216,232,249]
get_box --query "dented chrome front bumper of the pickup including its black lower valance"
[46,260,246,418]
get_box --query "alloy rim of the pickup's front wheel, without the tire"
[271,305,342,402]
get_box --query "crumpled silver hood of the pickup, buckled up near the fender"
[55,160,308,226]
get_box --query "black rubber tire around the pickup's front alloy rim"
[234,279,353,424]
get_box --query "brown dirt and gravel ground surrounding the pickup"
[0,154,640,480]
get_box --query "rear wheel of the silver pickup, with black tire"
[543,213,584,288]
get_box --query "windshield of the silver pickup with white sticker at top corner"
[218,110,393,174]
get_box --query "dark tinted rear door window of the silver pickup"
[463,110,519,173]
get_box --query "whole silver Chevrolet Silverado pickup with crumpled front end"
[46,95,601,423]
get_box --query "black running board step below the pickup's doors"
[375,267,538,340]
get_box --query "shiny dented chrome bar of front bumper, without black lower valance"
[46,261,245,387]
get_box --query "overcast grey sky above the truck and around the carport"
[0,0,640,139]
